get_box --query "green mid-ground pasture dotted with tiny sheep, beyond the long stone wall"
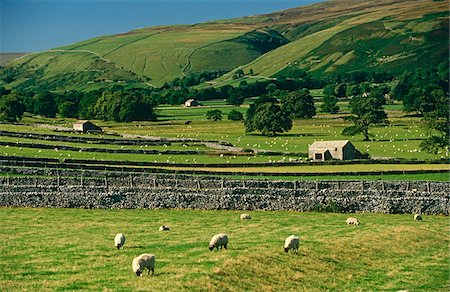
[0,98,449,181]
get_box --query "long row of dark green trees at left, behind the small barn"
[0,87,158,122]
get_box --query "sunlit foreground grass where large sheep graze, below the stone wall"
[0,208,450,291]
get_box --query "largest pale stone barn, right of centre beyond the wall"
[308,140,361,161]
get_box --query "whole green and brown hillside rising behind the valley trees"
[0,0,449,90]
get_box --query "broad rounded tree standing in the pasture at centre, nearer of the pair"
[245,96,292,135]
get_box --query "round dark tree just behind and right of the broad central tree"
[282,89,316,119]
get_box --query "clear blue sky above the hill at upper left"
[0,0,323,52]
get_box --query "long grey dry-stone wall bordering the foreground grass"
[0,174,450,215]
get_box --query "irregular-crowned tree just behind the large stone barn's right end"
[342,92,387,141]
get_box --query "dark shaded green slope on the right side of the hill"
[298,13,449,74]
